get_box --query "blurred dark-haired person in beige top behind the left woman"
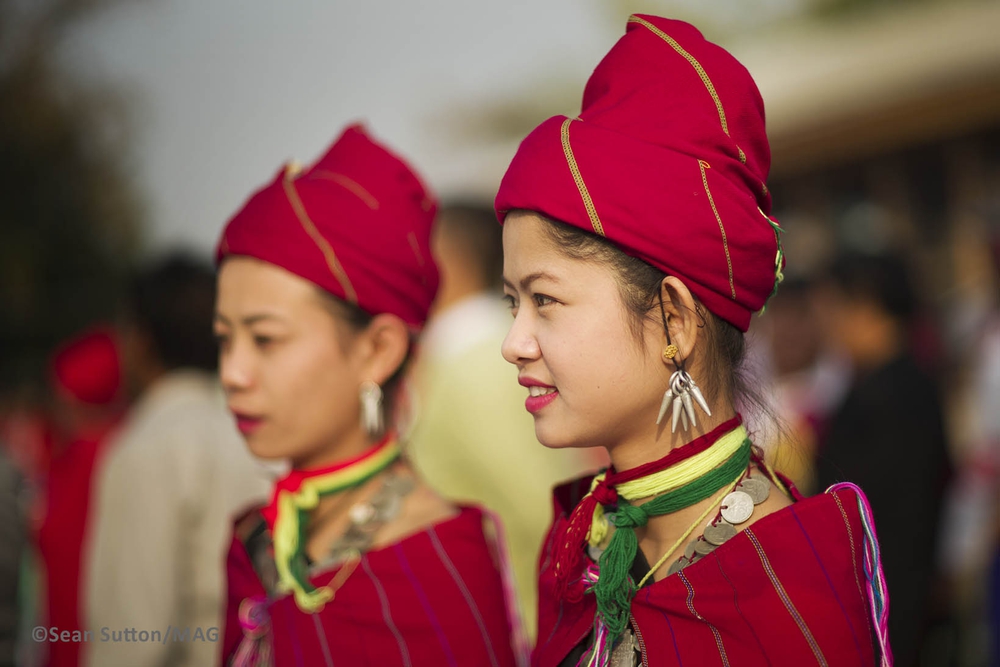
[84,255,269,667]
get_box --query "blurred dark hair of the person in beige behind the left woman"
[126,253,219,371]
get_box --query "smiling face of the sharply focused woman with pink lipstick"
[503,211,669,447]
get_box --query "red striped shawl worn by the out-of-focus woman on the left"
[223,507,516,667]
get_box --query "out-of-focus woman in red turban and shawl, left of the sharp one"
[215,127,516,666]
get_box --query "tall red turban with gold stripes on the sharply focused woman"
[496,15,784,331]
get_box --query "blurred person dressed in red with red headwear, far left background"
[37,328,125,667]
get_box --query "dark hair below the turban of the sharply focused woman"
[546,219,767,412]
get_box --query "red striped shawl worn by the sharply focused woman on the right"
[532,479,878,667]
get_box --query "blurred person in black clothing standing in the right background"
[817,252,950,667]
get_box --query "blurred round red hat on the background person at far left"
[51,328,122,405]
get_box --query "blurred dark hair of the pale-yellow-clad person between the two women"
[436,203,503,289]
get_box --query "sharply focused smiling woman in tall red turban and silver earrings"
[496,16,892,667]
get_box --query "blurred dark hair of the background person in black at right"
[829,252,917,324]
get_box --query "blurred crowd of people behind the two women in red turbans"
[0,189,1000,667]
